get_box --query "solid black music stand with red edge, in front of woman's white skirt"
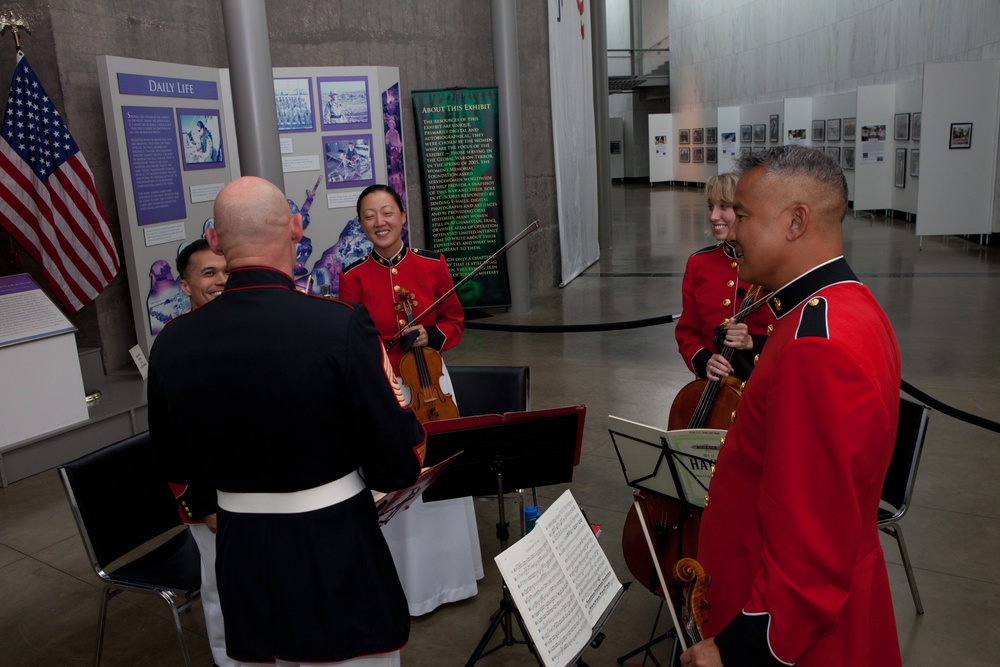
[424,405,587,667]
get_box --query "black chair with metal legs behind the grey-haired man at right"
[878,398,930,614]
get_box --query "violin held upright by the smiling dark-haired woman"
[395,288,459,424]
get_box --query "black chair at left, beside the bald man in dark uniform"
[59,432,201,667]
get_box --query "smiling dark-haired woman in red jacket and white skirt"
[339,185,483,616]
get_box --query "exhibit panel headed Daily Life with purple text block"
[97,56,239,354]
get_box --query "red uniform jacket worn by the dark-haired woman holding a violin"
[338,246,465,375]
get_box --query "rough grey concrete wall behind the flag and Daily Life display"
[0,0,559,372]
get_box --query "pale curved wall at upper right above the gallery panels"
[669,0,1000,112]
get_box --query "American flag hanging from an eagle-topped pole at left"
[0,52,118,312]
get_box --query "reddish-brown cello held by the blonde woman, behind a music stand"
[622,286,766,606]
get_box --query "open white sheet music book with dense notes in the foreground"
[494,491,623,667]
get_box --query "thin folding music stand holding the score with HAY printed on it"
[608,416,721,667]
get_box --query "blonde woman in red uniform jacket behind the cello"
[674,174,774,380]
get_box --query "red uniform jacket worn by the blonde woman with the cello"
[674,243,774,380]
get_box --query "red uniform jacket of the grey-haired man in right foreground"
[698,258,901,667]
